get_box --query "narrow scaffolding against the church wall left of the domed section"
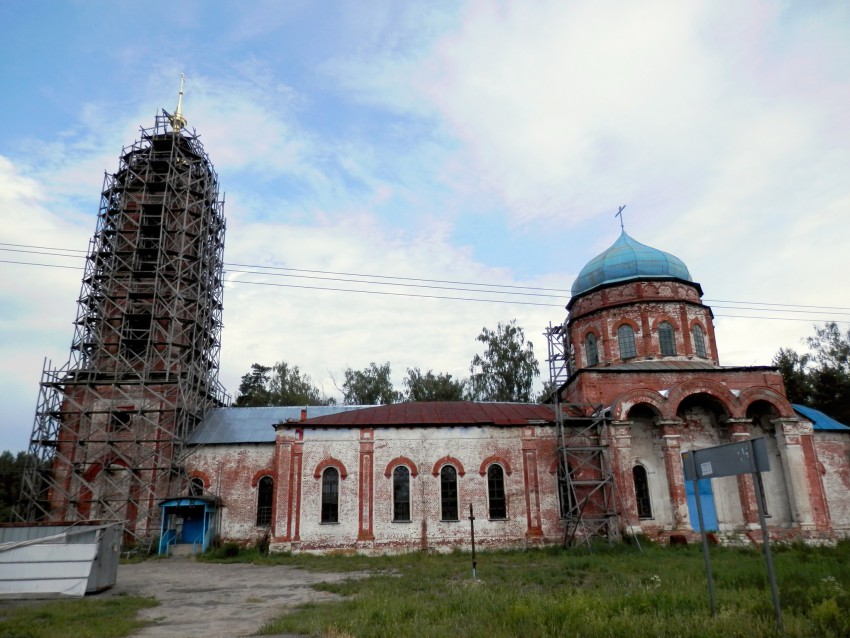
[544,323,620,548]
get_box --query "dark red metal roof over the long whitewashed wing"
[303,401,555,427]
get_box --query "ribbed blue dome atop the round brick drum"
[571,231,693,297]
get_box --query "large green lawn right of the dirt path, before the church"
[248,542,850,638]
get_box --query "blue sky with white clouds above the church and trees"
[0,0,850,450]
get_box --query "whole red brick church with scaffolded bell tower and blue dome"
[22,89,850,553]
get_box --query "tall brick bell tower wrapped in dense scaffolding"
[18,107,229,543]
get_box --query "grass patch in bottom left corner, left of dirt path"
[0,596,159,638]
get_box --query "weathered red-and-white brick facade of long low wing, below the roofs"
[192,404,563,551]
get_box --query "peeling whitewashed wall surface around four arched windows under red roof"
[292,427,558,547]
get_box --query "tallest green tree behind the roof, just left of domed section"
[469,319,540,403]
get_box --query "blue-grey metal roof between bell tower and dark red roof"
[189,405,371,445]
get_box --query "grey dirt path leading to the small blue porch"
[105,557,358,638]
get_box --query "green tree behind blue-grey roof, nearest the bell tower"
[234,361,334,407]
